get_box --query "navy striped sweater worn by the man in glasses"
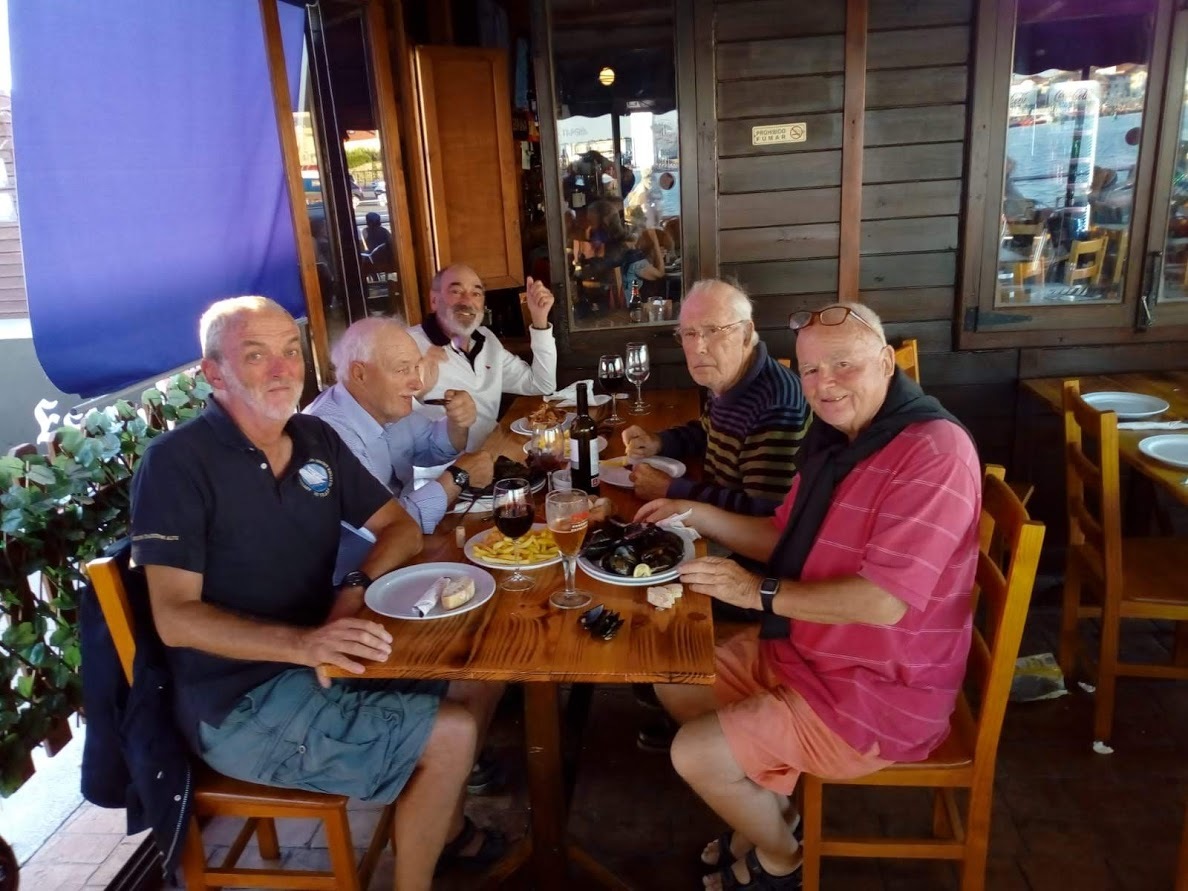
[661,341,813,516]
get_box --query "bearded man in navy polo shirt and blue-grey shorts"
[132,297,500,889]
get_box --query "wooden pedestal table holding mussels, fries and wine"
[328,388,714,891]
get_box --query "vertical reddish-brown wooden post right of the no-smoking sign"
[838,0,870,301]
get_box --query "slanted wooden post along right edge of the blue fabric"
[259,0,330,390]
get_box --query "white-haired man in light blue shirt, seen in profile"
[305,316,494,533]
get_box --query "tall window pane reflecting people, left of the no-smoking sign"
[552,0,682,328]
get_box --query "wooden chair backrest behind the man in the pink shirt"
[956,465,1044,775]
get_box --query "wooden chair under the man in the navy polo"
[87,557,394,891]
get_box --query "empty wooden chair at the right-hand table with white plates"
[1060,380,1188,743]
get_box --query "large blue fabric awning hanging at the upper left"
[8,0,305,397]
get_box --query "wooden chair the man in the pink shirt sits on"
[801,466,1044,891]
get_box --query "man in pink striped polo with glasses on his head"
[637,303,981,889]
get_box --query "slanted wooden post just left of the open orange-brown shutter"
[364,0,421,324]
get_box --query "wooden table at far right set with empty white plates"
[1023,371,1188,504]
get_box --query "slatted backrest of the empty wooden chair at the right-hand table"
[1063,380,1121,590]
